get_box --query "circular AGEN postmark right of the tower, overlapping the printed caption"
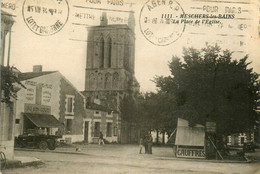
[139,0,185,46]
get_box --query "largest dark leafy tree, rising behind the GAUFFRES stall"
[154,45,260,135]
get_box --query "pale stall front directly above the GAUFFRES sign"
[175,118,205,146]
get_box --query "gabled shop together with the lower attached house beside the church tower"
[15,66,120,143]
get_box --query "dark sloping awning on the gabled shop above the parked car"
[24,113,63,128]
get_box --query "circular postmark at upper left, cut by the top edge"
[22,0,69,36]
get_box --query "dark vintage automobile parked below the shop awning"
[15,129,60,150]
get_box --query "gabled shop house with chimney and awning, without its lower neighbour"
[15,66,86,142]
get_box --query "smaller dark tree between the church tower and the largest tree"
[120,89,179,144]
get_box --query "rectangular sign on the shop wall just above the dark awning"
[24,103,51,114]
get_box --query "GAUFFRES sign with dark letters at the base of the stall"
[177,147,205,158]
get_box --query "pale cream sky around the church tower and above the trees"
[2,0,260,92]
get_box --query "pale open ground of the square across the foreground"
[3,144,260,174]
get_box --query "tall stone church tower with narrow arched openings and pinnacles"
[84,13,139,110]
